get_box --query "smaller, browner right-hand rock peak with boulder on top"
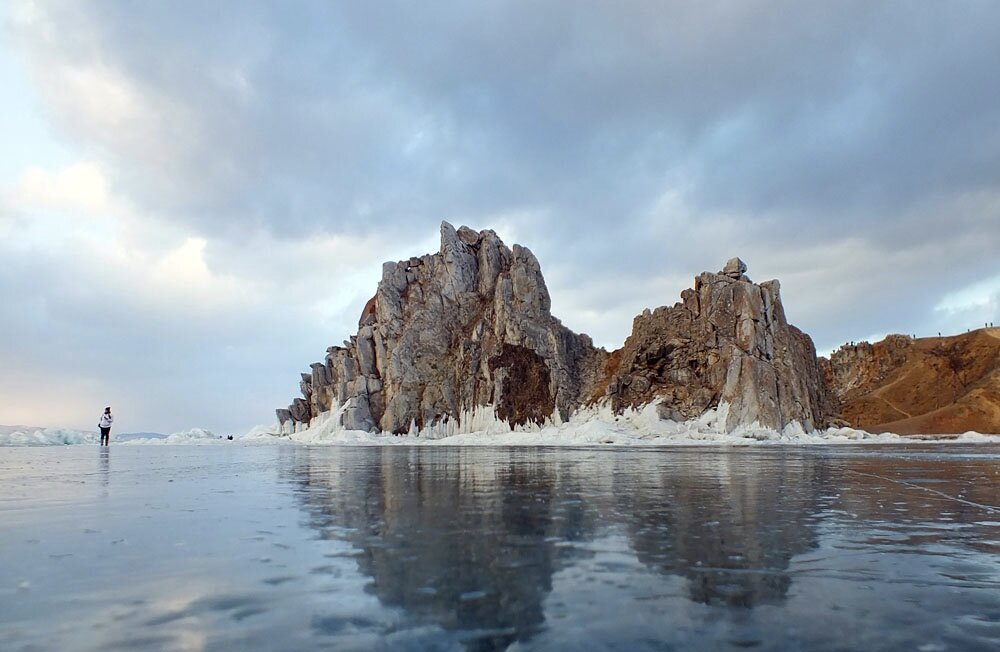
[605,258,831,430]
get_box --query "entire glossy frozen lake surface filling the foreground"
[0,443,1000,652]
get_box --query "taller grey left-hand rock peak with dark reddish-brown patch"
[279,222,607,433]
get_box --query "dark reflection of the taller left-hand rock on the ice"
[293,449,593,649]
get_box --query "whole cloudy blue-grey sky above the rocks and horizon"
[0,0,1000,434]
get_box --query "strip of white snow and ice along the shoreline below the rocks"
[0,405,1000,447]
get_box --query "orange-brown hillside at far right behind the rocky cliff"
[820,328,1000,434]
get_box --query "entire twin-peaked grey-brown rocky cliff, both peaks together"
[277,222,830,433]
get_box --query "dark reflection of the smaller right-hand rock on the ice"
[623,456,822,607]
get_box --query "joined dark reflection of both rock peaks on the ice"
[300,449,820,612]
